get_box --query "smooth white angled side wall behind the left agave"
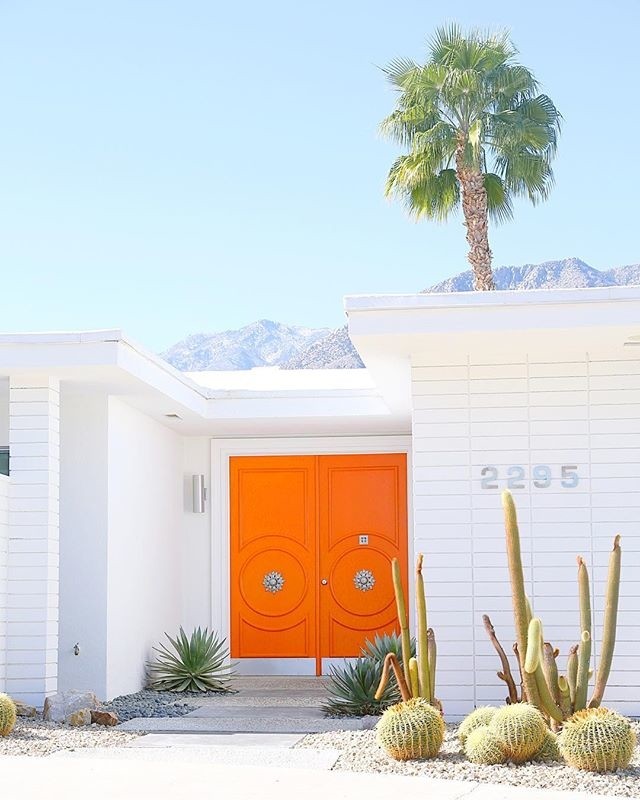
[106,397,181,697]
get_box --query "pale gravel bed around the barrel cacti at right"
[296,723,640,798]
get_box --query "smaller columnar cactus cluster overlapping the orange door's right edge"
[375,554,440,708]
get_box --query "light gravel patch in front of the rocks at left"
[0,718,139,757]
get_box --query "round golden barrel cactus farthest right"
[558,707,636,772]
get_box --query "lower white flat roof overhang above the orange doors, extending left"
[0,330,410,436]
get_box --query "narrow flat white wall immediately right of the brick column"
[58,389,108,698]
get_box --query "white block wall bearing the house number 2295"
[413,354,640,716]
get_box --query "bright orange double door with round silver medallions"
[230,453,407,674]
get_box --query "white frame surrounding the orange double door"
[210,435,414,675]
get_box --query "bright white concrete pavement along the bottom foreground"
[1,748,620,800]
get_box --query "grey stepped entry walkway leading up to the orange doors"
[120,677,377,733]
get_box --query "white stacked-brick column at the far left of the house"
[6,376,60,705]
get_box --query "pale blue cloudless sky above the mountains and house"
[0,0,640,349]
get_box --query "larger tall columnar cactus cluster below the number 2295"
[498,492,621,725]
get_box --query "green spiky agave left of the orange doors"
[147,627,233,692]
